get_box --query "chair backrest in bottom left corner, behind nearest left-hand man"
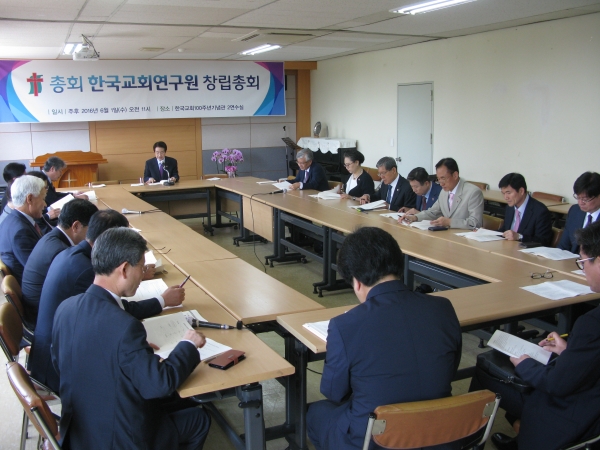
[6,362,60,450]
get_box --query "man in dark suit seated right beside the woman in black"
[360,156,417,211]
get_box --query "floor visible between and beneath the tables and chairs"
[0,219,514,450]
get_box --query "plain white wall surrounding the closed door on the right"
[311,14,600,198]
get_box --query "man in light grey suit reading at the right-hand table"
[404,158,483,229]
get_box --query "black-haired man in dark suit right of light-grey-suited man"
[498,173,552,247]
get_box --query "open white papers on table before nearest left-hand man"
[142,311,231,360]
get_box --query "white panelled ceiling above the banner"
[0,0,600,61]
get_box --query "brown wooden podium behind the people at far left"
[30,150,108,188]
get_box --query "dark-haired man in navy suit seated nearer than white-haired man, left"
[21,198,98,330]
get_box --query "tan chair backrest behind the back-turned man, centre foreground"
[363,390,500,449]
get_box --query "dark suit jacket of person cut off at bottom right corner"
[515,307,600,450]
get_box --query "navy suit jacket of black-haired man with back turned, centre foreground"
[321,281,462,449]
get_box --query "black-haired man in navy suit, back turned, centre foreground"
[306,227,462,450]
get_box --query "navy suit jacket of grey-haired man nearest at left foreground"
[52,285,200,450]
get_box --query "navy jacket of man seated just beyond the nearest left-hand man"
[27,240,162,390]
